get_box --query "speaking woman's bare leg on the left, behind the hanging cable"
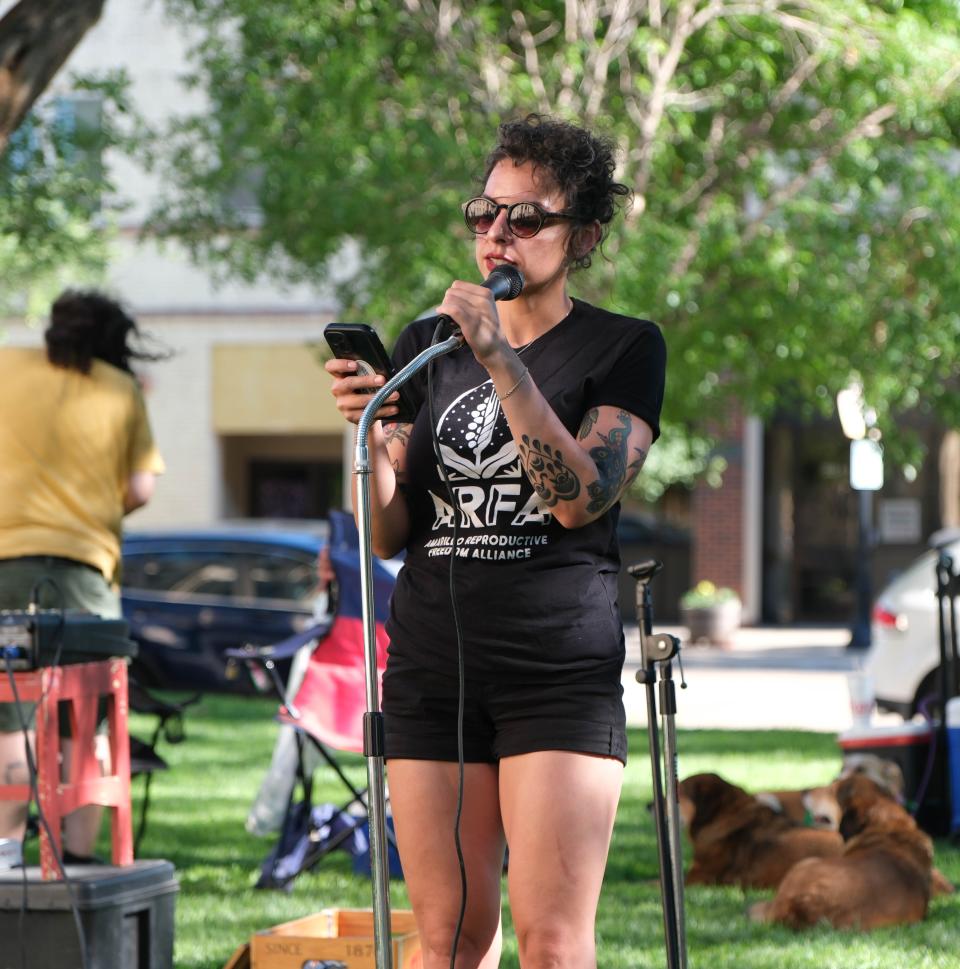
[387,760,504,969]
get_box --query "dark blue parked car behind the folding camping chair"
[122,522,328,694]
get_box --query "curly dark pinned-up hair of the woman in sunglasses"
[480,114,632,269]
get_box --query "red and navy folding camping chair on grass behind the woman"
[229,511,396,888]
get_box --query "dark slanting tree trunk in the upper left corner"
[0,0,106,155]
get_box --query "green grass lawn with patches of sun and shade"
[114,697,960,969]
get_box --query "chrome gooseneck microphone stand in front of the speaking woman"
[353,334,463,969]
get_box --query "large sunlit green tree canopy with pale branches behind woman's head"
[155,0,960,488]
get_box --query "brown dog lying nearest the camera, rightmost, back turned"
[750,774,949,930]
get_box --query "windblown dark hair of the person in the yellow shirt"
[44,289,169,373]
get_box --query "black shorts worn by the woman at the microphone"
[383,656,627,763]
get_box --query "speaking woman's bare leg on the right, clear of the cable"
[500,750,623,969]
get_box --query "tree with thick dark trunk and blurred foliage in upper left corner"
[0,0,142,314]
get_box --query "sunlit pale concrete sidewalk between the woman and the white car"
[623,625,903,733]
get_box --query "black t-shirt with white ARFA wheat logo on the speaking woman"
[387,300,666,679]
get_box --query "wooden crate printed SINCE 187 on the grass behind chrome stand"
[244,908,423,969]
